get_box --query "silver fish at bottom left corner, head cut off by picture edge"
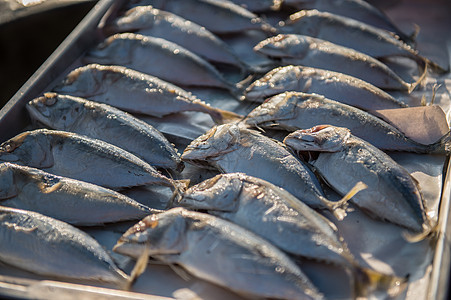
[0,206,129,286]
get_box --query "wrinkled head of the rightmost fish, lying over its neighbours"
[283,125,351,152]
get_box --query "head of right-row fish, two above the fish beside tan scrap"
[254,34,310,59]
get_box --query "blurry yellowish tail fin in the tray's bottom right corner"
[354,266,408,299]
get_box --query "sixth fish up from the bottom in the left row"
[83,33,236,91]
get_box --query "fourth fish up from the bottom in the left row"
[26,93,184,171]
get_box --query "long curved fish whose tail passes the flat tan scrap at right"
[243,92,451,154]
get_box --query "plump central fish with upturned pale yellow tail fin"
[182,123,352,218]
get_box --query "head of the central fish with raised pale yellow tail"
[182,123,240,163]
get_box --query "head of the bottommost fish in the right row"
[113,207,191,258]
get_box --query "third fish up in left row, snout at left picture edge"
[0,129,175,189]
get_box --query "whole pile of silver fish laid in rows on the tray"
[0,0,451,299]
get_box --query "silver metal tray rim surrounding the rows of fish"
[0,0,451,299]
